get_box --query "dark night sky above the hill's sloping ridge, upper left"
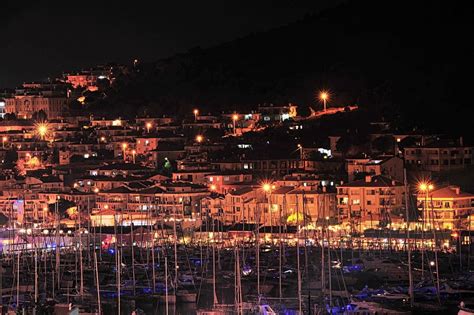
[0,0,342,87]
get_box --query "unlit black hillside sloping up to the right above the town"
[96,0,474,137]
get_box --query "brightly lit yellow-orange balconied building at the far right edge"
[417,186,474,230]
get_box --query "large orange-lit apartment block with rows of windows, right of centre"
[337,175,405,232]
